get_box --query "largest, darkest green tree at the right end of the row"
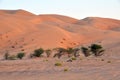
[90,44,104,56]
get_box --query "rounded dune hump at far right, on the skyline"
[76,17,120,30]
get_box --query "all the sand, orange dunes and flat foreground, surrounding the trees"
[0,10,120,80]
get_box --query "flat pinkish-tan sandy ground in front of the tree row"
[0,57,120,80]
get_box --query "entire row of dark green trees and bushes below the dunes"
[4,44,104,60]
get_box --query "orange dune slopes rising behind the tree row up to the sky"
[0,10,120,54]
